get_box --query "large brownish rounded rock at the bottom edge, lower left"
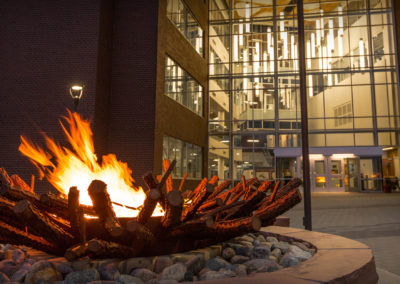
[25,261,63,284]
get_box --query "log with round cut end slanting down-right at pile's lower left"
[14,200,73,245]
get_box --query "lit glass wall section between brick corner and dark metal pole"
[209,0,300,180]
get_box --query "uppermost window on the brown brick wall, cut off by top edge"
[167,0,204,56]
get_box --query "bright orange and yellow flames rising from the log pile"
[19,111,163,217]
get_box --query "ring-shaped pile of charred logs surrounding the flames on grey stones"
[0,163,301,260]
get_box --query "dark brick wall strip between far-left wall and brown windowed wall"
[108,0,158,186]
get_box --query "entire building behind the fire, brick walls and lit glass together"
[0,0,400,191]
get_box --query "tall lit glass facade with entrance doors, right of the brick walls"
[208,0,400,191]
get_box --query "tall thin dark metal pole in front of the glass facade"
[297,0,312,231]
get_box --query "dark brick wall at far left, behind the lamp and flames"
[0,0,99,193]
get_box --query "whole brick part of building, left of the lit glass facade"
[0,0,209,192]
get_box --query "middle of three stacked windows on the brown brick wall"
[165,56,203,116]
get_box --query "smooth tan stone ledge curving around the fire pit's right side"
[201,226,378,284]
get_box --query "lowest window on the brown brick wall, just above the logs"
[163,136,203,179]
